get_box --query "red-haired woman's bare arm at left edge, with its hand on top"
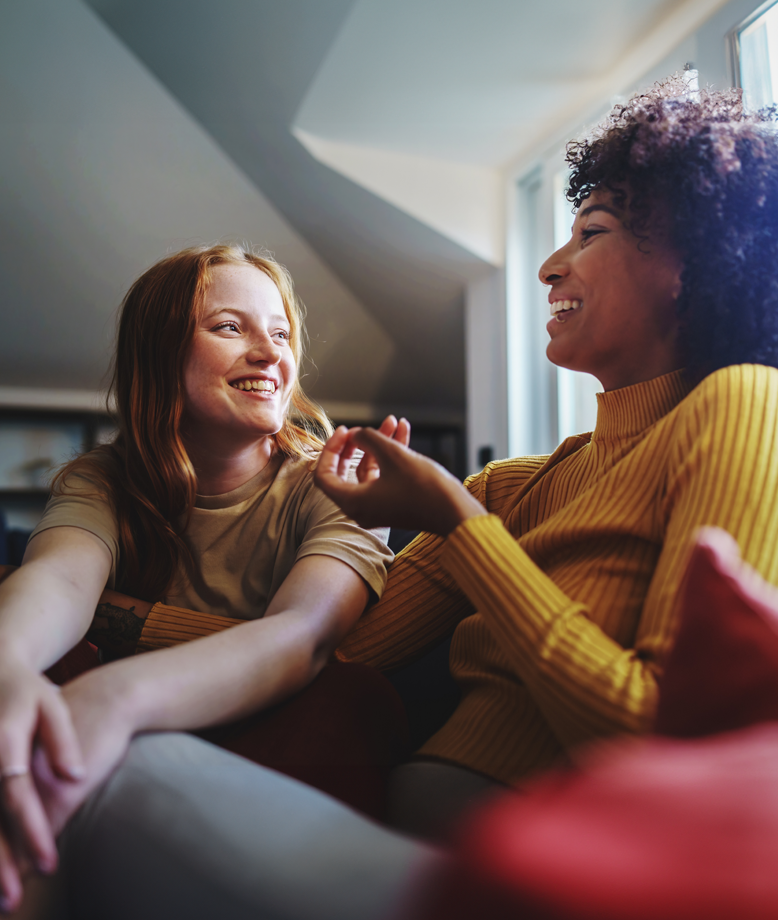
[0,527,111,904]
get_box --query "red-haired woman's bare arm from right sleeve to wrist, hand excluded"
[80,556,368,732]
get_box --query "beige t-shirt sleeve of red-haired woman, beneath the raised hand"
[295,469,394,597]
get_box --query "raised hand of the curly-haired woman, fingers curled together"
[315,416,486,536]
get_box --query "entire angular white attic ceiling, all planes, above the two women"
[0,0,740,419]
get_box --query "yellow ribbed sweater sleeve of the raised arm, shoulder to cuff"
[440,365,778,746]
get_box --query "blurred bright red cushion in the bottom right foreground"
[419,724,778,920]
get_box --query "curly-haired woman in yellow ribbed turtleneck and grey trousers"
[13,78,778,920]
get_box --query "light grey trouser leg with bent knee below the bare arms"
[61,733,445,920]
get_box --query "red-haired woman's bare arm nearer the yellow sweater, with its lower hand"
[40,556,368,828]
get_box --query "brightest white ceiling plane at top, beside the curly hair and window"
[293,0,723,265]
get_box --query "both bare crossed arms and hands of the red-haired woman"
[0,527,368,908]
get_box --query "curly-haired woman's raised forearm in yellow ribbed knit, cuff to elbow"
[442,517,656,746]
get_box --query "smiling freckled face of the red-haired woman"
[183,264,297,448]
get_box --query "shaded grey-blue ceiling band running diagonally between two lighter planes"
[83,0,487,411]
